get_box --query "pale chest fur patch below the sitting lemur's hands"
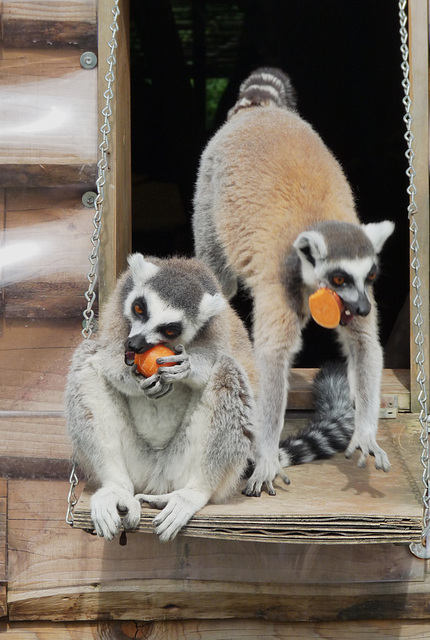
[129,385,192,449]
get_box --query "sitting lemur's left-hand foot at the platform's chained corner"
[91,487,140,540]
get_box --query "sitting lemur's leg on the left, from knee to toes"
[68,364,140,540]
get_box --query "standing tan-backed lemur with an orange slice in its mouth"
[193,68,394,495]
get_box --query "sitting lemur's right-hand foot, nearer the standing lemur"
[135,489,208,542]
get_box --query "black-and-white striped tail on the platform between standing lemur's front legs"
[279,362,354,467]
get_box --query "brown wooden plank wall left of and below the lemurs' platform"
[0,0,430,640]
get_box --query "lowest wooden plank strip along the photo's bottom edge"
[0,619,430,640]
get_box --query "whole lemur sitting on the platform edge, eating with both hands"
[66,254,256,541]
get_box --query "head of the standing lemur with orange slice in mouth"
[294,221,394,324]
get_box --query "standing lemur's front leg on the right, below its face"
[338,304,390,471]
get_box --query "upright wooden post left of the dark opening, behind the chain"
[98,0,131,304]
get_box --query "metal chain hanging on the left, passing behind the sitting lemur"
[66,0,120,525]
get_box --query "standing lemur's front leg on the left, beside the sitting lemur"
[244,283,301,496]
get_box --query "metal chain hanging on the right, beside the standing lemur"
[399,0,430,557]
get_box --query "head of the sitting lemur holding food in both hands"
[123,254,226,364]
